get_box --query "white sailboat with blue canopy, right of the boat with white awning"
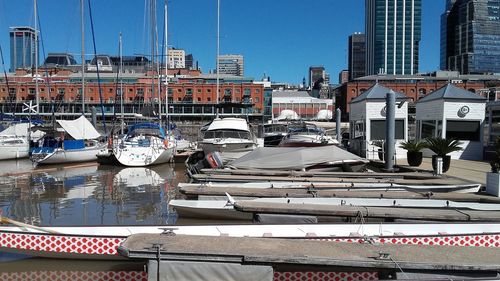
[112,123,175,167]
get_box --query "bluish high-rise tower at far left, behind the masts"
[10,26,37,72]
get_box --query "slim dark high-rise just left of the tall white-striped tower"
[348,32,366,80]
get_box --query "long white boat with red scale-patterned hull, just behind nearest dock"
[0,224,500,260]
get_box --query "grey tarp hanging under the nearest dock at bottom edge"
[148,260,273,281]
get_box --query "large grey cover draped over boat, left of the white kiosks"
[228,145,369,170]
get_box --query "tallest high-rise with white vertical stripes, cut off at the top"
[365,0,422,75]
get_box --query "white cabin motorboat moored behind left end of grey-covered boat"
[198,118,257,162]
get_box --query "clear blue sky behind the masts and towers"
[0,0,445,84]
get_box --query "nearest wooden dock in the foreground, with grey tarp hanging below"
[118,234,500,272]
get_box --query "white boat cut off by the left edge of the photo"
[0,123,44,160]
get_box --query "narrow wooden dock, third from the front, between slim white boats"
[179,184,500,203]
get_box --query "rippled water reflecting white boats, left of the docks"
[0,160,185,226]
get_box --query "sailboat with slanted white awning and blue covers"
[30,115,105,164]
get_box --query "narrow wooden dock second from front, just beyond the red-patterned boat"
[234,201,500,222]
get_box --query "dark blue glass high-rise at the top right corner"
[441,0,500,74]
